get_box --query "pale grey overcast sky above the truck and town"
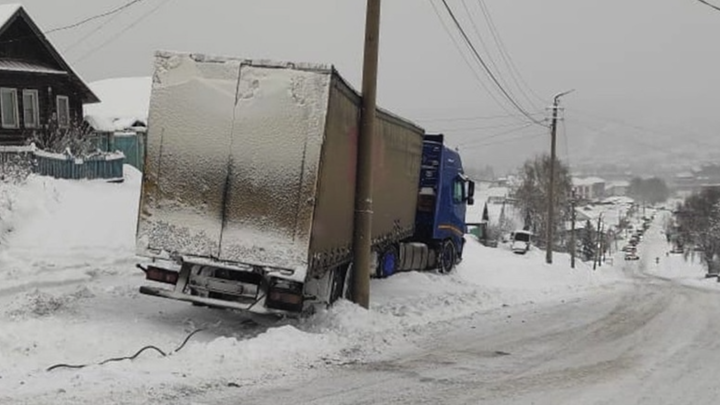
[8,0,720,169]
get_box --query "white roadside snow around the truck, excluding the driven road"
[0,166,640,404]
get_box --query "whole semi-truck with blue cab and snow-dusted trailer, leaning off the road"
[136,52,474,315]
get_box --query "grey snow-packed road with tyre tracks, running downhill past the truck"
[198,223,720,405]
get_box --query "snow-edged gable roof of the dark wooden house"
[0,4,100,104]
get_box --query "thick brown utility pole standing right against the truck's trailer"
[352,0,380,308]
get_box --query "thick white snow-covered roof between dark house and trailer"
[85,77,152,122]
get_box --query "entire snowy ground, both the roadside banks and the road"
[0,167,720,405]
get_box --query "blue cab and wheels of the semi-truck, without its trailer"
[377,135,475,277]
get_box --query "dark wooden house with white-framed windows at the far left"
[0,4,100,145]
